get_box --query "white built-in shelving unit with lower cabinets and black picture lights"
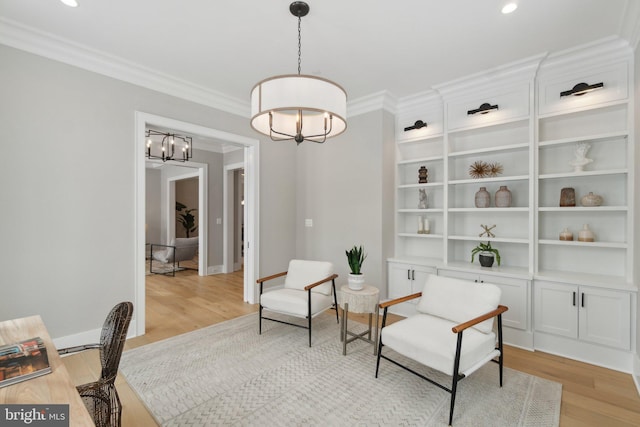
[388,39,637,371]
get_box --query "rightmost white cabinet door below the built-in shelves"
[579,287,631,349]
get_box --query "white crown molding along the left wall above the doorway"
[0,17,250,117]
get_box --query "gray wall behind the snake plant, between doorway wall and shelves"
[296,111,394,295]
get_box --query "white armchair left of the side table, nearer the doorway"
[257,259,339,347]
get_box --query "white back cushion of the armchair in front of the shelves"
[417,275,501,334]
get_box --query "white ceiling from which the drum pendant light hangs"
[0,0,640,105]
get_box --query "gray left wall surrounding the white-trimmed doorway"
[0,45,296,338]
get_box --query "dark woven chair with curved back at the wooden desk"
[58,302,133,427]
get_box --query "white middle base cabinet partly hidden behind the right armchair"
[438,270,529,330]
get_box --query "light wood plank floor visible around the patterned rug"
[64,271,640,427]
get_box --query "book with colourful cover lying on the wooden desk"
[0,337,51,387]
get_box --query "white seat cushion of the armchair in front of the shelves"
[382,314,497,375]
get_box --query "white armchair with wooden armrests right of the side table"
[376,275,508,425]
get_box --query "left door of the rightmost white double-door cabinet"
[533,281,578,338]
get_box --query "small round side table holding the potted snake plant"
[338,285,380,355]
